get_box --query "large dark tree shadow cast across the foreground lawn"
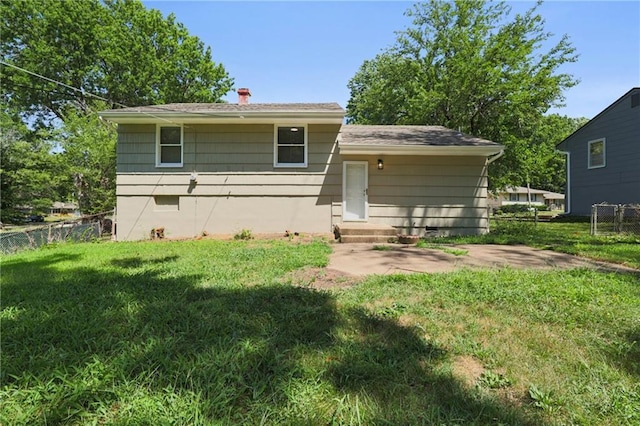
[0,251,543,424]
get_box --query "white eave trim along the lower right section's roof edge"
[340,144,504,157]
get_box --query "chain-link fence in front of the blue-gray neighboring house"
[591,203,640,235]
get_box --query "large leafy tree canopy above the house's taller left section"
[0,0,233,124]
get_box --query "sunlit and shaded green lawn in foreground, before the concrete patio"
[0,240,640,425]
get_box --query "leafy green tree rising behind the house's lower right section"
[347,0,577,187]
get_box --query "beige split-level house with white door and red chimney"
[101,89,503,240]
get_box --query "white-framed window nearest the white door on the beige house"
[273,124,309,167]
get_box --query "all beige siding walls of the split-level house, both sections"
[117,124,487,240]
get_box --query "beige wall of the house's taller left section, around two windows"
[117,124,342,240]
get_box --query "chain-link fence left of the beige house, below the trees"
[0,221,103,254]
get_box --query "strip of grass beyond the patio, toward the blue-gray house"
[438,220,640,269]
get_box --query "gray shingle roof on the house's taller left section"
[107,102,344,114]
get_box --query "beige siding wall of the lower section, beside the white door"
[332,156,488,235]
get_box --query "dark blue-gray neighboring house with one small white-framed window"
[557,87,640,216]
